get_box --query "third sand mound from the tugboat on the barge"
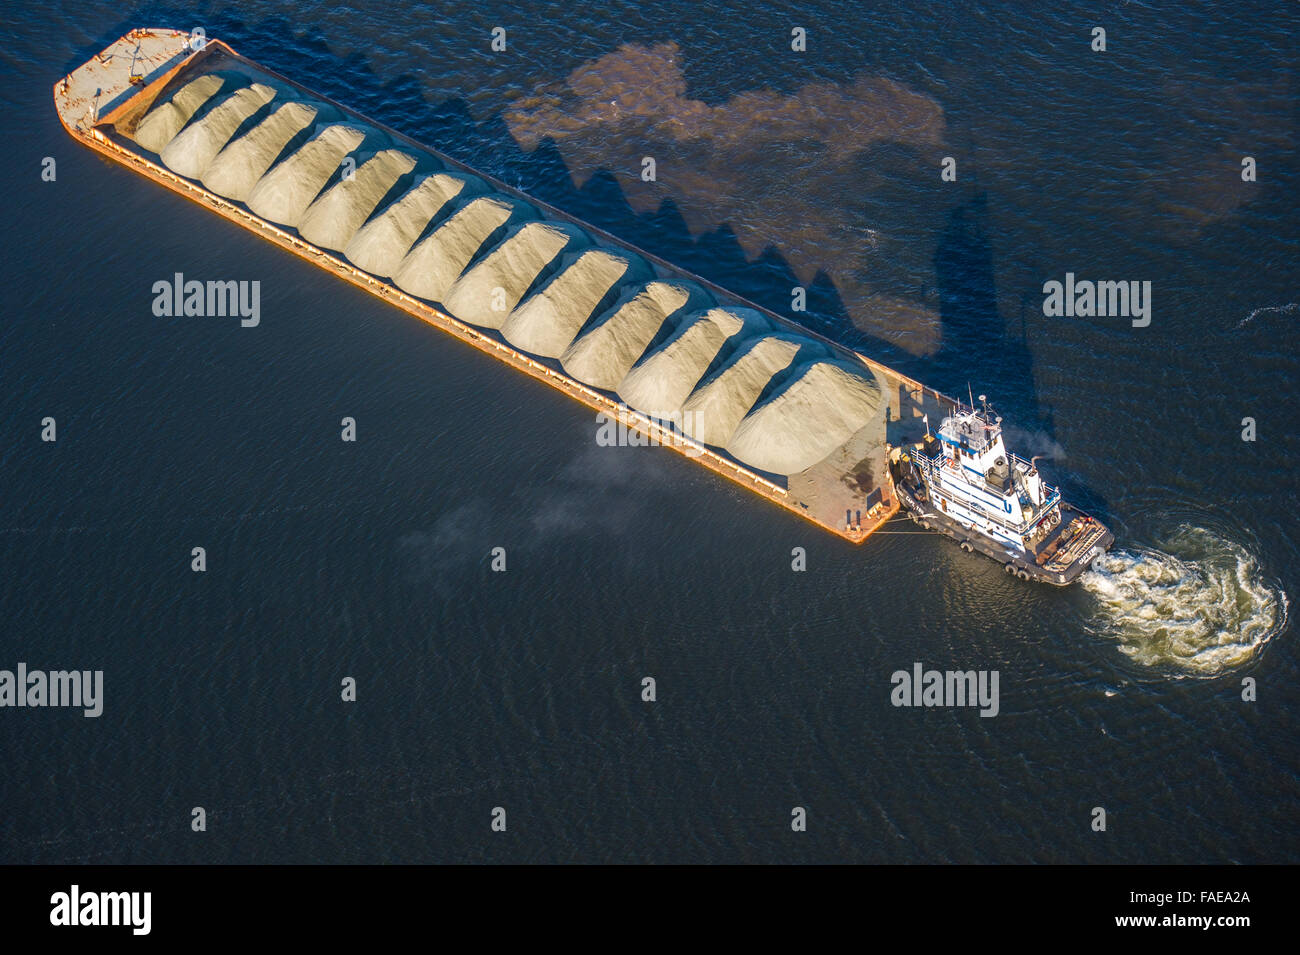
[619,308,768,421]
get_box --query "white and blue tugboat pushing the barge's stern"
[889,395,1115,586]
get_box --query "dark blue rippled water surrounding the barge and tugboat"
[0,0,1300,863]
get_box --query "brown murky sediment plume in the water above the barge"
[503,43,946,355]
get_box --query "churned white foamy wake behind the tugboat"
[1080,526,1287,677]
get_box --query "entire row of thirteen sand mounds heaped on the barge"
[135,74,884,474]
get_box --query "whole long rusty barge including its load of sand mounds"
[55,29,957,543]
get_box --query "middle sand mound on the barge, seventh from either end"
[393,195,537,301]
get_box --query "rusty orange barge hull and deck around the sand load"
[53,29,957,543]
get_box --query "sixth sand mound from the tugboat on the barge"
[443,222,592,329]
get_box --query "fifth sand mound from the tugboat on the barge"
[501,248,651,359]
